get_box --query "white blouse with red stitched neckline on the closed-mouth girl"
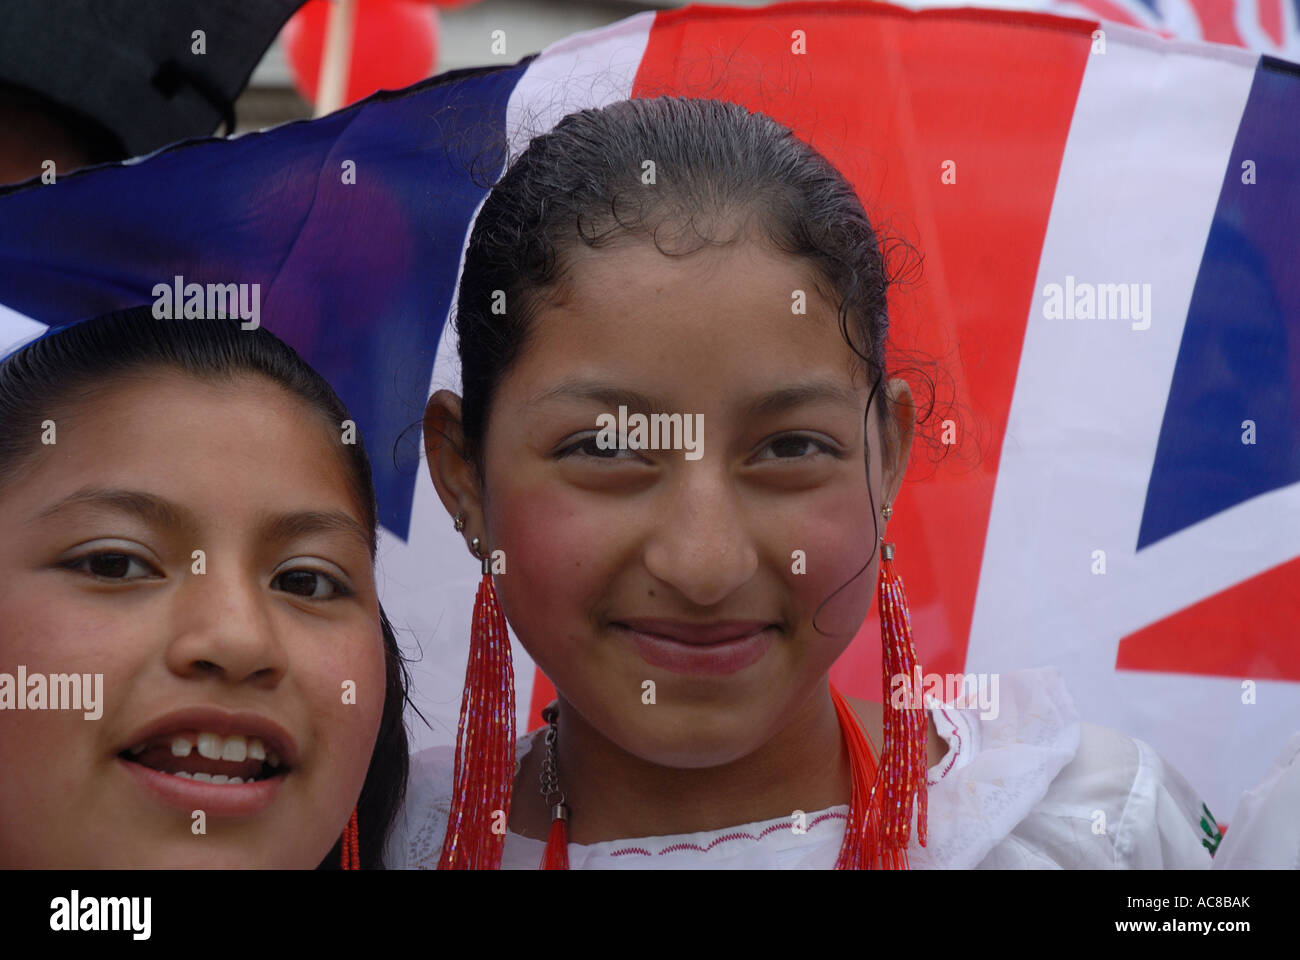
[384,667,1217,870]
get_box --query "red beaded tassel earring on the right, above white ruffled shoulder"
[831,503,930,870]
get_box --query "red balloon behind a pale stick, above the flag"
[281,0,438,104]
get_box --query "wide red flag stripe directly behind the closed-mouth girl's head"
[532,1,1097,712]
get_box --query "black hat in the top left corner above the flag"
[0,0,306,155]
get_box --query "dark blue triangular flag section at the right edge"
[1138,57,1300,550]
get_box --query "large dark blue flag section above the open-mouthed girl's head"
[0,57,533,539]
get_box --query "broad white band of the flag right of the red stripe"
[967,23,1300,817]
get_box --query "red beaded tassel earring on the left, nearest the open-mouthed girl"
[438,514,515,870]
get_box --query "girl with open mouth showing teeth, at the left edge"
[0,307,407,868]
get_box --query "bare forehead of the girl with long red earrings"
[503,243,862,393]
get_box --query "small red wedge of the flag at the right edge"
[1115,558,1300,683]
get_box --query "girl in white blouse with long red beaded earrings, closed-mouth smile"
[390,98,1210,868]
